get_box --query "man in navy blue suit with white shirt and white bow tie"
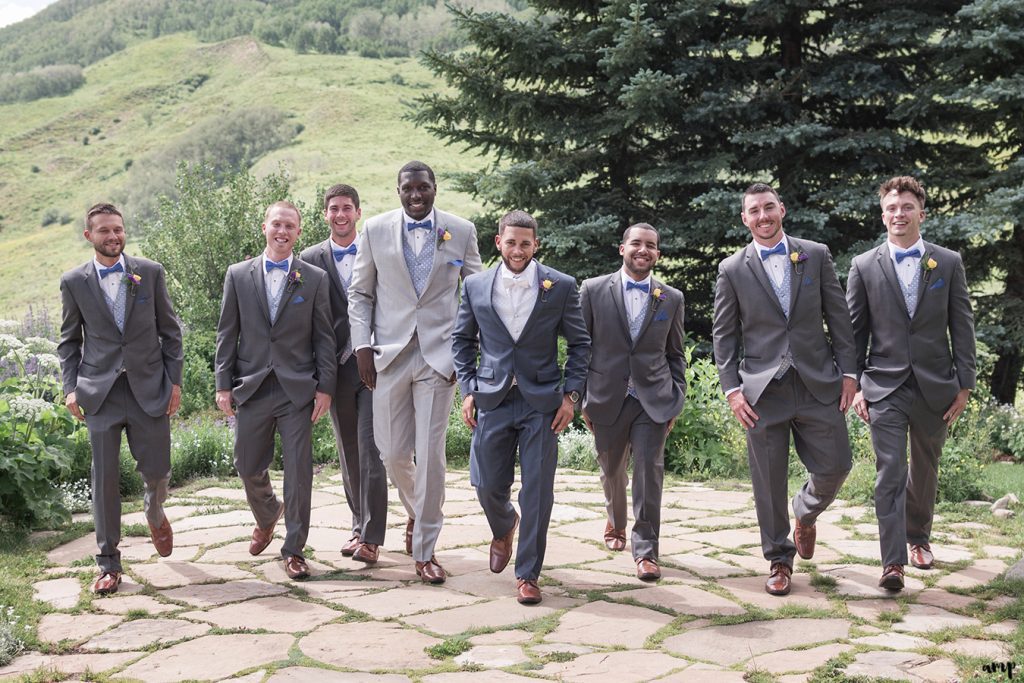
[452,211,590,604]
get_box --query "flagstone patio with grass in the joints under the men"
[0,472,1020,683]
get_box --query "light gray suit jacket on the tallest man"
[348,208,482,377]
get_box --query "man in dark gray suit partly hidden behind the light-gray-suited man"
[300,184,387,564]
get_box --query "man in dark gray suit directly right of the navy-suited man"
[580,223,686,581]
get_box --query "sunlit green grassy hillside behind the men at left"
[0,34,480,316]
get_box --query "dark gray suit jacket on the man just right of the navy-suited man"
[580,270,686,425]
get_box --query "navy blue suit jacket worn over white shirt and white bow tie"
[451,263,590,413]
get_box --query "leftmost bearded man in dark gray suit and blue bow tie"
[57,204,182,594]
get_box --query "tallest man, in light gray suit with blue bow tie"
[348,162,480,584]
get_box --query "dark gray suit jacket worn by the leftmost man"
[57,254,183,417]
